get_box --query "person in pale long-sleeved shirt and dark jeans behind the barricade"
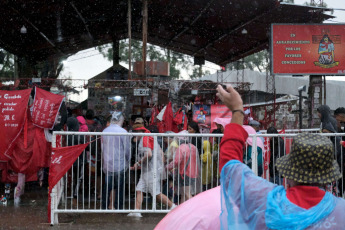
[102,111,131,209]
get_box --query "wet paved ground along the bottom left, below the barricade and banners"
[0,184,165,230]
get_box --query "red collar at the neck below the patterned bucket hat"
[286,185,326,209]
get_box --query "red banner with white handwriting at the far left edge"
[0,89,31,160]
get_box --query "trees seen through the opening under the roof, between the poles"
[97,39,193,79]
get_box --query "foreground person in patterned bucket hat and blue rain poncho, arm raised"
[217,86,345,229]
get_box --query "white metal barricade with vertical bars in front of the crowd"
[51,129,344,224]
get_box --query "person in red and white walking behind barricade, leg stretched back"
[128,124,176,217]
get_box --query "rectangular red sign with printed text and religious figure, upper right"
[271,24,345,75]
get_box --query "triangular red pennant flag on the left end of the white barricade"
[49,143,89,190]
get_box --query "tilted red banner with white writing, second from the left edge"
[32,87,64,129]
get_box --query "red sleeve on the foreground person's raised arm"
[219,123,248,172]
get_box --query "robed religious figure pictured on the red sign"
[314,34,339,68]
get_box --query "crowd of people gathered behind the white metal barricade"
[60,97,345,223]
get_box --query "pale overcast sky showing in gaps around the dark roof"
[60,0,345,101]
